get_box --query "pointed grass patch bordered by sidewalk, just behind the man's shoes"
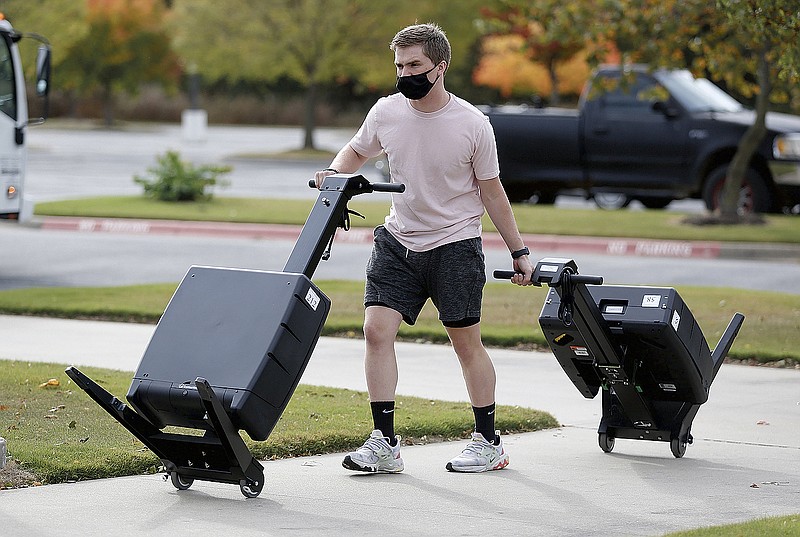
[0,361,558,489]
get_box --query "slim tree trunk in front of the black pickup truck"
[719,51,772,222]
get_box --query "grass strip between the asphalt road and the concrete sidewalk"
[0,281,800,362]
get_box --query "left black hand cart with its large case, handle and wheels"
[66,174,405,498]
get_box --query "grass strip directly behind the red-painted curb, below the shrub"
[35,196,800,244]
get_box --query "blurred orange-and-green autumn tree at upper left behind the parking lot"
[59,0,180,125]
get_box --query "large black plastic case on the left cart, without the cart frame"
[127,266,330,440]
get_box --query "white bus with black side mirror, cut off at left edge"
[0,14,50,219]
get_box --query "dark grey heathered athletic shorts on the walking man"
[364,226,486,328]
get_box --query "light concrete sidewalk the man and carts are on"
[0,316,800,536]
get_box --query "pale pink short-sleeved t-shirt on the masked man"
[350,93,500,252]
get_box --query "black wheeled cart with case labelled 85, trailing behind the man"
[494,258,744,458]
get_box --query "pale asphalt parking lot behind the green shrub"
[24,124,380,201]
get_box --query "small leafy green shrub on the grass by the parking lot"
[133,151,233,201]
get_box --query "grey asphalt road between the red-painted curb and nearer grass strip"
[0,223,800,294]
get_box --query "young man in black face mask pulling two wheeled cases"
[315,24,533,473]
